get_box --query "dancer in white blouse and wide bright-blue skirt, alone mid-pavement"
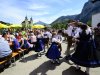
[46,32,62,64]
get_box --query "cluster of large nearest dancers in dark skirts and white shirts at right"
[65,22,100,75]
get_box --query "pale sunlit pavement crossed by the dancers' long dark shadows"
[0,43,100,75]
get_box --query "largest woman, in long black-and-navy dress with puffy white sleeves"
[71,25,100,75]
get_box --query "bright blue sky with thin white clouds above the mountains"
[0,0,88,24]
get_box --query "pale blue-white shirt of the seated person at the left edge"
[0,37,12,58]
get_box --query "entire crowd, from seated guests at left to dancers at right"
[0,21,100,75]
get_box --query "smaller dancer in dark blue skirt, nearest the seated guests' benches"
[35,31,44,57]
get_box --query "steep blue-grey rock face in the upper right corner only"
[75,0,100,23]
